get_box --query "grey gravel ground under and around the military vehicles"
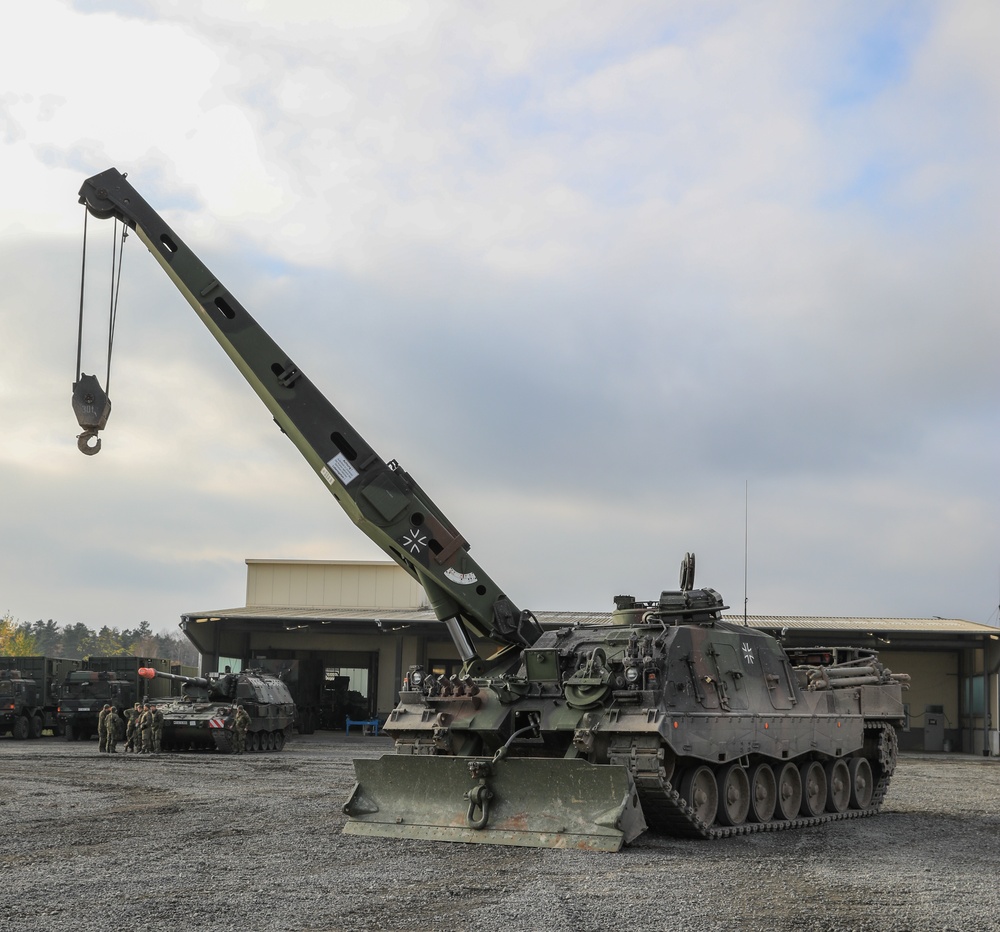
[0,733,1000,932]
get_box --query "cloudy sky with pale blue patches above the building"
[0,0,1000,630]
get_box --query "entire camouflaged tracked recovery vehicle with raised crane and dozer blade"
[73,169,903,850]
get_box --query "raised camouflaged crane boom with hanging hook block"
[74,168,541,673]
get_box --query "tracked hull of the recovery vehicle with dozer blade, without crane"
[344,624,905,851]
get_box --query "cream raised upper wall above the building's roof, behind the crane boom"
[246,560,427,609]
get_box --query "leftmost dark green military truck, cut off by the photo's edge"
[0,655,80,739]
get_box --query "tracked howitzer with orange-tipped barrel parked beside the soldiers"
[139,667,295,754]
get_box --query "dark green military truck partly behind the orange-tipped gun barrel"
[58,656,181,741]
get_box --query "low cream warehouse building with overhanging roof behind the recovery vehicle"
[181,559,1000,756]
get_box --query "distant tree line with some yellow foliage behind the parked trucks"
[0,613,198,666]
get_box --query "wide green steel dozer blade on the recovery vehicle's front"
[344,754,646,851]
